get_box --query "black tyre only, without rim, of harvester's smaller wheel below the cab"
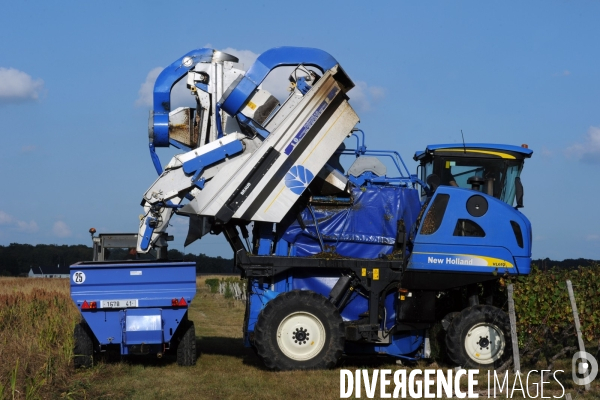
[446,305,512,369]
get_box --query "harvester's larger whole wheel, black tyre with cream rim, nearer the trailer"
[254,290,346,371]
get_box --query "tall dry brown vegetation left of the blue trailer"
[0,278,79,398]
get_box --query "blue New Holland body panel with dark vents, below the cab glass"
[407,186,531,275]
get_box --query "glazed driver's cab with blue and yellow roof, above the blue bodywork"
[414,143,533,207]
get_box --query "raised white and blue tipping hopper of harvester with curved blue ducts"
[138,47,358,252]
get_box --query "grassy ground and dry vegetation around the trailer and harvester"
[0,277,600,399]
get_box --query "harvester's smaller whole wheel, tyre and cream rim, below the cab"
[446,305,512,369]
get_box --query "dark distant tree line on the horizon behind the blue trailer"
[0,243,234,276]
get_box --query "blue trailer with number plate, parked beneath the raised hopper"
[71,261,196,368]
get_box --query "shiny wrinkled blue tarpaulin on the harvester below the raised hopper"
[282,186,421,258]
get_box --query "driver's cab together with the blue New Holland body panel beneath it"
[407,143,533,278]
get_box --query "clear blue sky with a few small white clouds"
[0,0,600,259]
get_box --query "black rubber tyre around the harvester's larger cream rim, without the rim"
[254,290,346,371]
